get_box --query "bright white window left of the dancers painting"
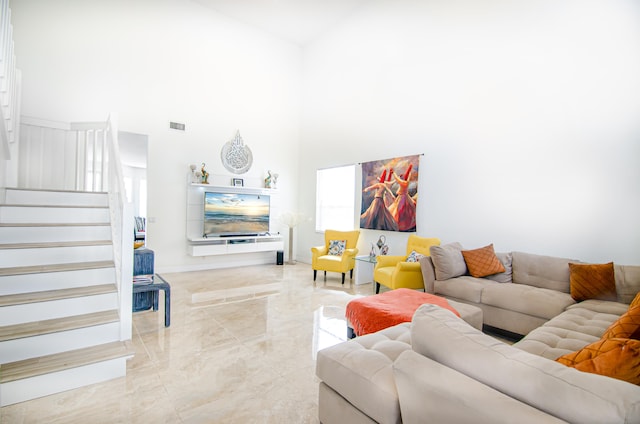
[316,165,356,231]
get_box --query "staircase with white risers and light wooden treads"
[0,188,133,406]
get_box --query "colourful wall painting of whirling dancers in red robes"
[360,155,421,232]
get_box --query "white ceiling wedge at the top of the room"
[193,0,370,46]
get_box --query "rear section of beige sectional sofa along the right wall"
[420,247,640,335]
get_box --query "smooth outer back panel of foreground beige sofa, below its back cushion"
[393,350,564,424]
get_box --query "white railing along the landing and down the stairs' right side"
[18,114,134,340]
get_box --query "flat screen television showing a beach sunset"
[203,192,270,237]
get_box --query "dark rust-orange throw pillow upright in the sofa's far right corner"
[569,262,617,302]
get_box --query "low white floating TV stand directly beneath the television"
[189,234,284,256]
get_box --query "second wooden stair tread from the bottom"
[0,310,120,342]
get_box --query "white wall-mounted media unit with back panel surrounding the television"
[187,184,284,256]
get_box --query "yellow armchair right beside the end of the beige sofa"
[373,234,440,293]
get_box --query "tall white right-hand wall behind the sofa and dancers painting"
[298,0,640,264]
